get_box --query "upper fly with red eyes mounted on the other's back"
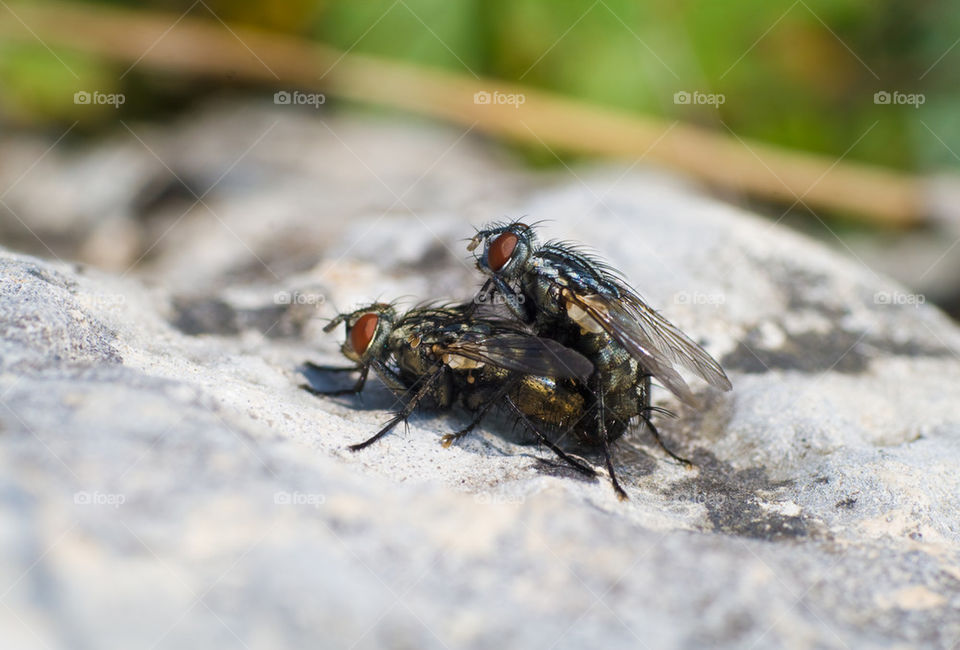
[467,222,732,498]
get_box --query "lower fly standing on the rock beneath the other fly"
[301,303,595,476]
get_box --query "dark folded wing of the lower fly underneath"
[438,333,593,381]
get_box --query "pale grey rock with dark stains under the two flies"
[0,104,960,649]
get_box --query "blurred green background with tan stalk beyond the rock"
[0,0,960,317]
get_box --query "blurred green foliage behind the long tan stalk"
[0,0,960,169]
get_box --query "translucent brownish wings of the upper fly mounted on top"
[566,286,732,403]
